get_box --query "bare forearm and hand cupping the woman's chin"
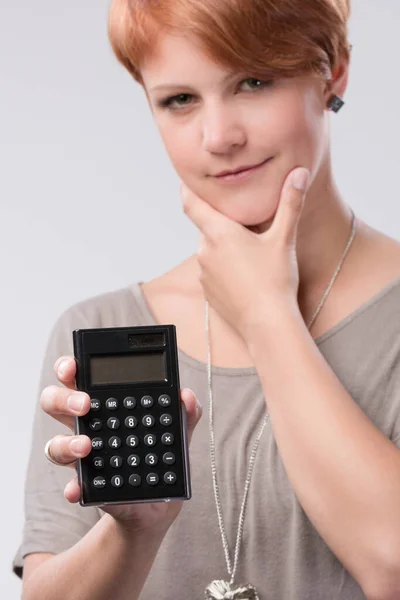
[182,169,400,600]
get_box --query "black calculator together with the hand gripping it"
[41,325,202,527]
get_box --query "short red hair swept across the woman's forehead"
[108,0,350,86]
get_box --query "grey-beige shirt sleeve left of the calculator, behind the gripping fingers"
[12,307,103,578]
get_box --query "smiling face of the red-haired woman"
[141,35,329,230]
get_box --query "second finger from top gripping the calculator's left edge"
[40,385,90,431]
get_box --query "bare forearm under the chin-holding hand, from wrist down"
[248,311,400,600]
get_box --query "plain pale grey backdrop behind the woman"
[0,0,400,600]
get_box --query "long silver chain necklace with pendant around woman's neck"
[205,209,356,600]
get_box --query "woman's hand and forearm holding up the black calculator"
[22,356,202,600]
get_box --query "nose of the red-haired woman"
[203,104,246,154]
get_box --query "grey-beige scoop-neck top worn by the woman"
[12,278,400,600]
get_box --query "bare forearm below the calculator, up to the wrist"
[22,513,168,600]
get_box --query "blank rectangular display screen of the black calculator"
[90,351,168,385]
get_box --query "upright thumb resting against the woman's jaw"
[266,167,310,245]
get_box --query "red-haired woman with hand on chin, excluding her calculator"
[14,0,400,600]
